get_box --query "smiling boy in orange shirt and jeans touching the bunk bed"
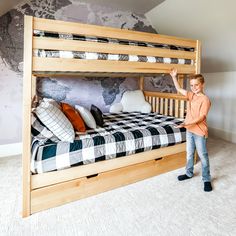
[170,69,212,192]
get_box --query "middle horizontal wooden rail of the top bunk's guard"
[33,37,196,60]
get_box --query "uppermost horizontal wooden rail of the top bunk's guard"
[34,18,196,48]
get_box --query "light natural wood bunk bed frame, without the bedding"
[22,16,200,217]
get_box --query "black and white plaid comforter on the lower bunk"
[31,112,186,173]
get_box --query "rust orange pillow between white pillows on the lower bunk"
[61,103,86,132]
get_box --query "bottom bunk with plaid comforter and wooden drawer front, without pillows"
[30,112,185,213]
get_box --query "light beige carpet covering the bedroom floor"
[0,138,236,236]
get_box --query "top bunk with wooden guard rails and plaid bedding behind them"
[24,16,200,77]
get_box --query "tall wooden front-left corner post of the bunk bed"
[22,16,33,217]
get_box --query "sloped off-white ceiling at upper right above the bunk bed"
[145,0,236,72]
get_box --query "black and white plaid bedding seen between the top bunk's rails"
[33,30,194,65]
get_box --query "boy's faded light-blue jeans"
[186,131,211,182]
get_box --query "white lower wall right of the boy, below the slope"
[204,71,236,143]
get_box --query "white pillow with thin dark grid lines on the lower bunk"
[35,99,75,142]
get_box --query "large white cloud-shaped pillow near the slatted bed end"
[121,90,152,113]
